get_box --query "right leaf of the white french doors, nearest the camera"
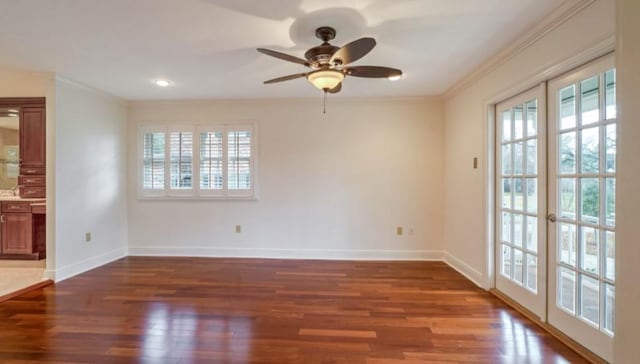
[548,57,617,361]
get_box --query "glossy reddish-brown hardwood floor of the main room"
[0,257,584,364]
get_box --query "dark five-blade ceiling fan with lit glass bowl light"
[258,27,402,94]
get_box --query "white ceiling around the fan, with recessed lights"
[0,0,562,99]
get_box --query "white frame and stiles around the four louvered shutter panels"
[136,122,258,200]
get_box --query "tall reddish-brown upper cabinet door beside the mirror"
[20,107,47,170]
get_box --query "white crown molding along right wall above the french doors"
[442,0,596,100]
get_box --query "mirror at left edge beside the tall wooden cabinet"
[0,107,20,190]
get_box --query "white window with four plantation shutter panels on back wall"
[139,124,256,199]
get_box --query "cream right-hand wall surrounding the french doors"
[444,0,614,287]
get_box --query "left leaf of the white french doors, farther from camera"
[496,84,547,319]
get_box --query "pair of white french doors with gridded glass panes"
[495,56,617,361]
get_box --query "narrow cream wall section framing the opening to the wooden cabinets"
[0,67,56,275]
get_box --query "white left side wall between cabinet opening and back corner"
[53,78,127,281]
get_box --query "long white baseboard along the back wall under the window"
[129,247,444,260]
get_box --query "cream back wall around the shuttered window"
[129,93,443,259]
